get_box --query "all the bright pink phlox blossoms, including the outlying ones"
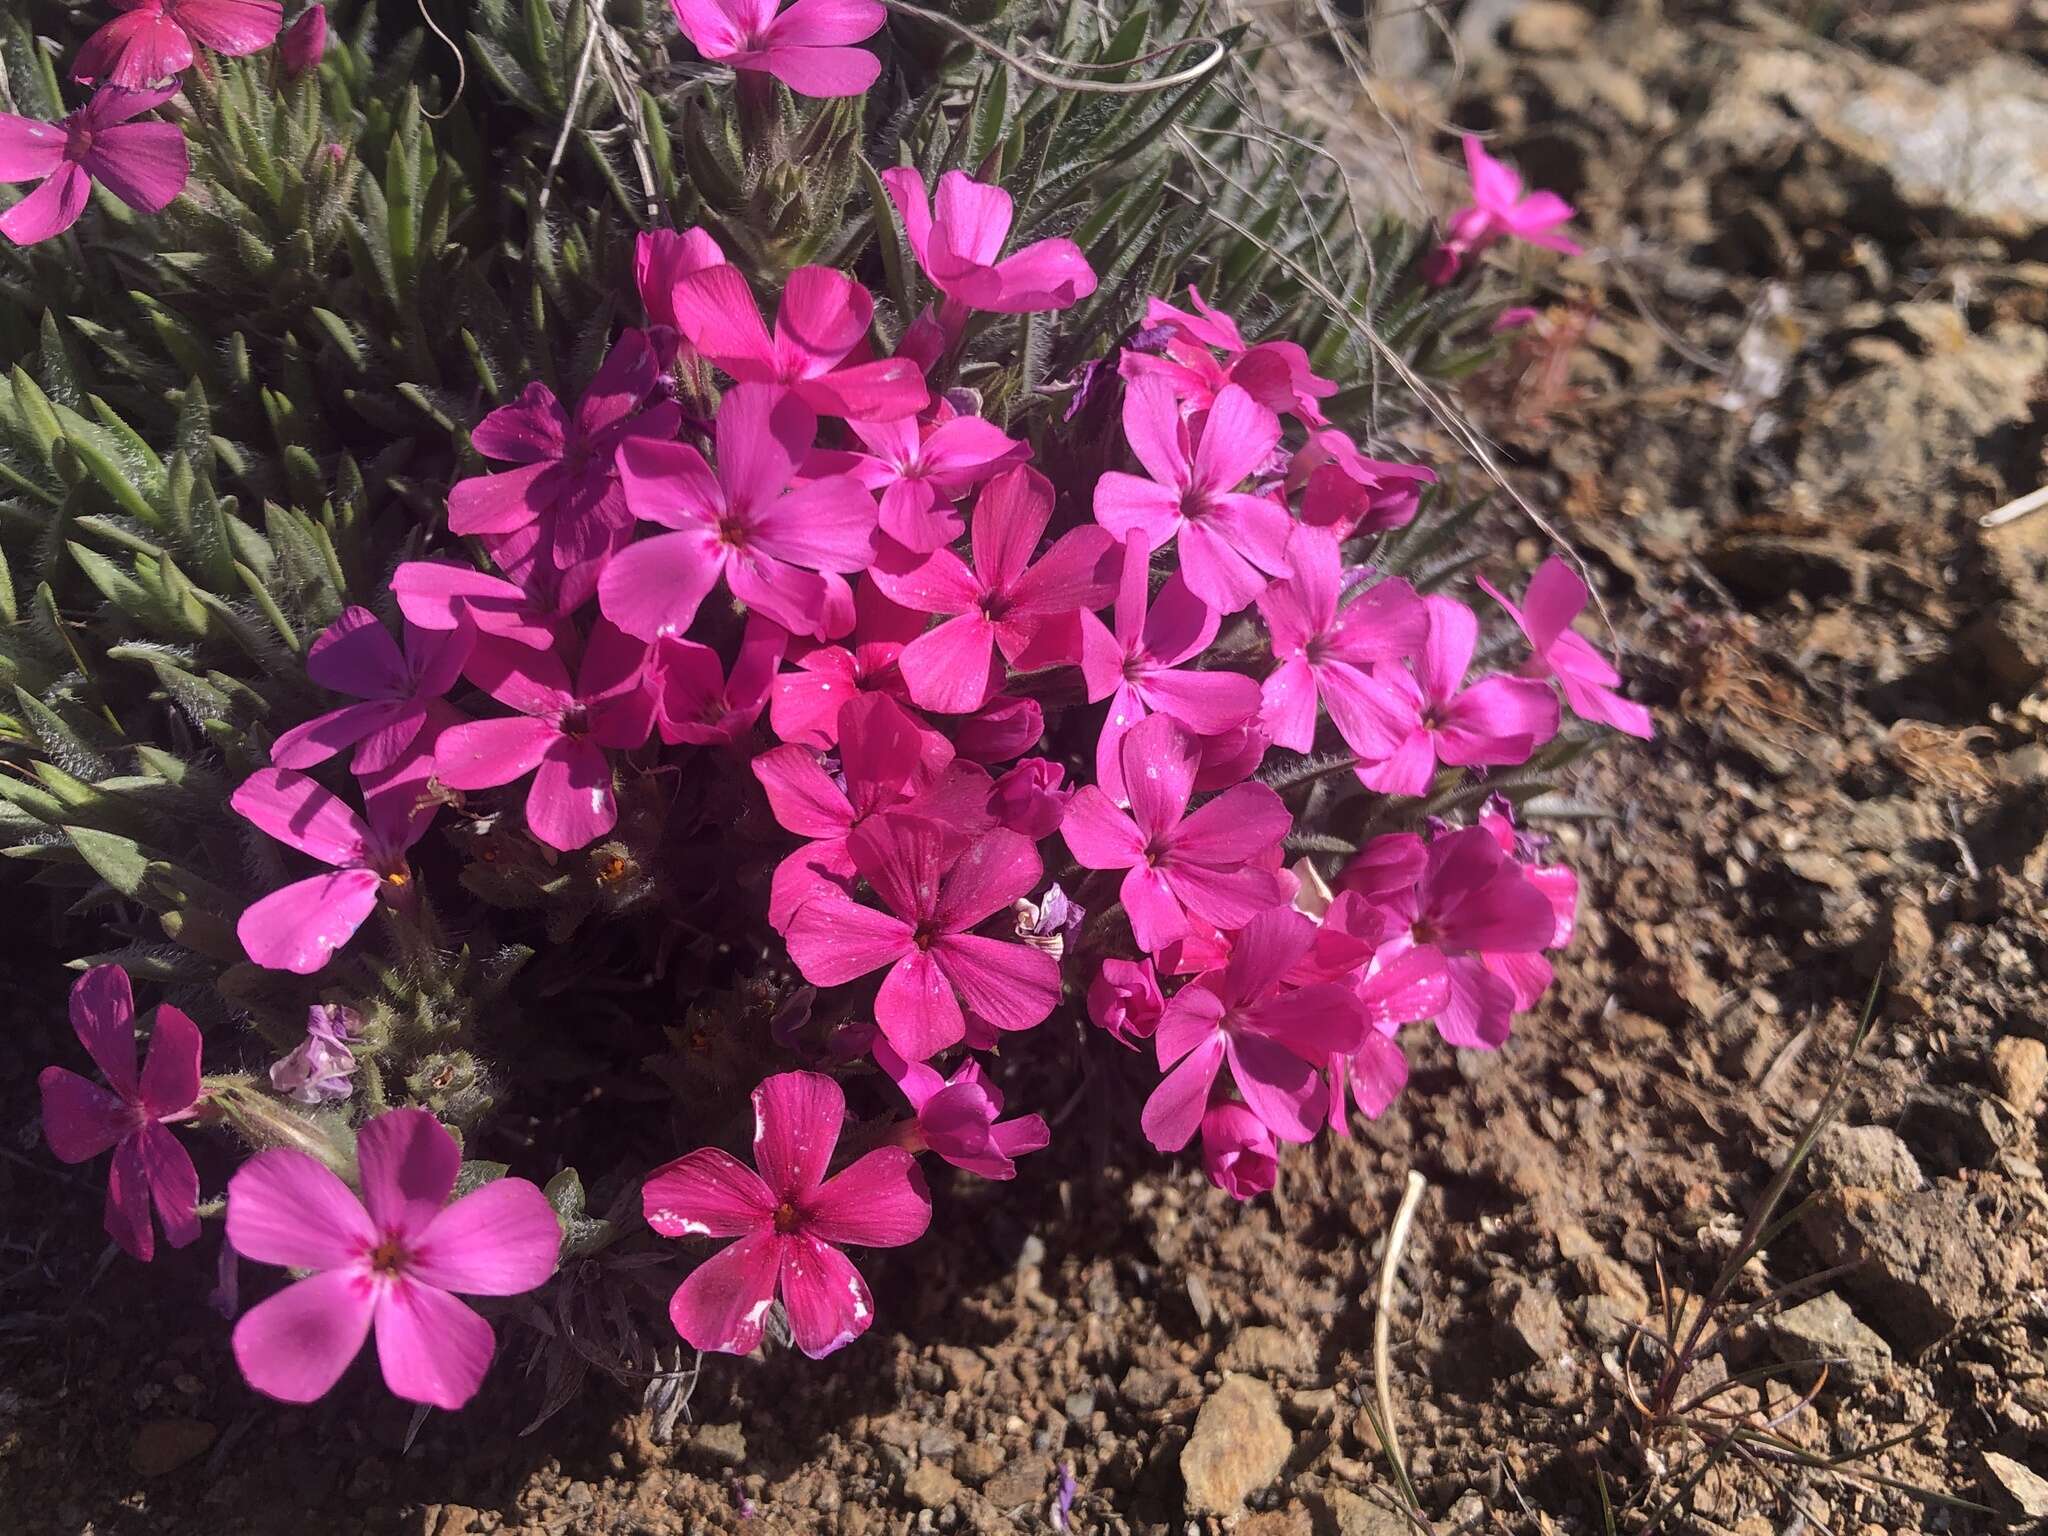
[19,0,1613,1407]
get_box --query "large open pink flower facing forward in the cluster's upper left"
[598,385,874,639]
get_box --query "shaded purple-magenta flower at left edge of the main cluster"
[270,608,475,774]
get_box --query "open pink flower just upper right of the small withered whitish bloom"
[1059,715,1294,958]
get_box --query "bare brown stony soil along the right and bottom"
[0,0,2048,1536]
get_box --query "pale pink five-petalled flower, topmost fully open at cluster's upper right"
[1096,377,1294,614]
